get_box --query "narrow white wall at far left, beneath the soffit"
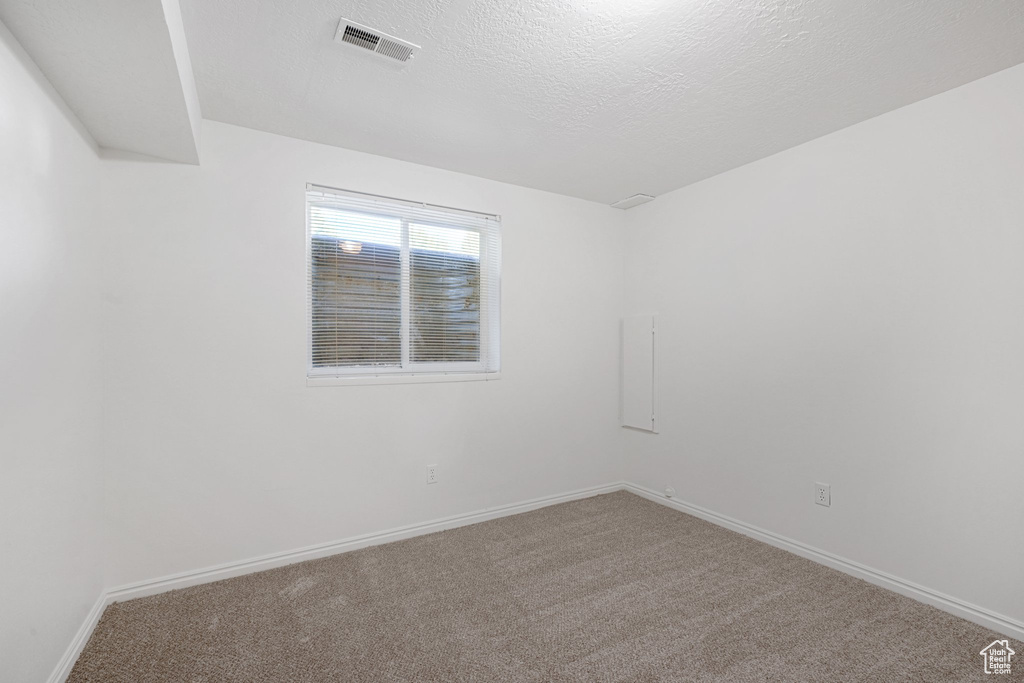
[0,24,103,681]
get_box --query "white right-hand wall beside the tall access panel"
[625,66,1024,620]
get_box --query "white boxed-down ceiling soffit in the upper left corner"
[0,0,202,163]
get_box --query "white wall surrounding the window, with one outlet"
[103,122,623,586]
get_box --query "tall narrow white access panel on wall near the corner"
[622,315,657,432]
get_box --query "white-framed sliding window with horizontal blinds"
[306,185,501,381]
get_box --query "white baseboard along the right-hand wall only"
[623,482,1024,640]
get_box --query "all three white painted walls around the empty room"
[0,13,1024,681]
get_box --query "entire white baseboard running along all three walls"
[48,481,1024,683]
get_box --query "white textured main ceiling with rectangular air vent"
[182,0,1024,204]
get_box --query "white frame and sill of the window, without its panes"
[305,183,501,387]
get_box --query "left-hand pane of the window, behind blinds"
[309,205,401,368]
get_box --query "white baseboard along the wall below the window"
[106,482,625,604]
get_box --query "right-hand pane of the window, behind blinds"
[409,223,480,362]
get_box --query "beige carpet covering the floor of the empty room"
[70,492,1024,683]
